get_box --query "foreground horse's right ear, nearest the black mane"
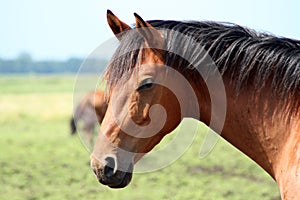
[134,13,164,56]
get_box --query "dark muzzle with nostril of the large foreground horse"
[91,156,133,188]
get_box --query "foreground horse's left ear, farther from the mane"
[107,10,131,40]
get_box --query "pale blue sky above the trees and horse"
[0,0,300,60]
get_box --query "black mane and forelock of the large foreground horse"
[105,20,300,111]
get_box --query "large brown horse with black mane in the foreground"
[90,10,300,199]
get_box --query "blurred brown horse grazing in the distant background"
[70,90,107,145]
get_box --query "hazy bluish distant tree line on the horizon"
[0,53,107,74]
